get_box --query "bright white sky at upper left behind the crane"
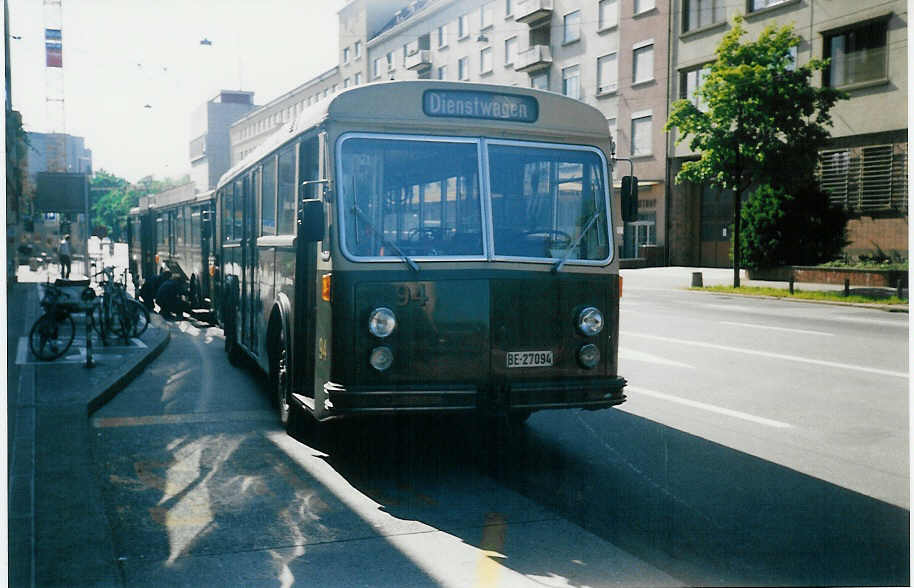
[8,0,345,182]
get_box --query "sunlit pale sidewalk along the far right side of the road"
[619,266,908,312]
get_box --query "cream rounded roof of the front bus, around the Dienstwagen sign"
[217,80,610,189]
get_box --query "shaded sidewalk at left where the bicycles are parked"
[7,268,169,587]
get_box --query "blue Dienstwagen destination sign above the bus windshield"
[422,90,539,122]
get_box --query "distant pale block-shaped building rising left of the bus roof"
[190,90,257,191]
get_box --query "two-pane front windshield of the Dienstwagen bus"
[339,136,610,265]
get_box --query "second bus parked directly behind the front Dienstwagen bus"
[127,183,216,310]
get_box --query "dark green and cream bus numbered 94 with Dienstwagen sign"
[213,80,637,429]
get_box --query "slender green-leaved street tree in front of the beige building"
[666,16,843,287]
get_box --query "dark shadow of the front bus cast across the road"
[316,411,910,586]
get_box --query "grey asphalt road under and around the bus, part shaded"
[87,276,910,586]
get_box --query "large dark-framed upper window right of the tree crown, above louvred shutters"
[825,20,888,87]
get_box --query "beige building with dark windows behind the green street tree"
[667,0,908,267]
